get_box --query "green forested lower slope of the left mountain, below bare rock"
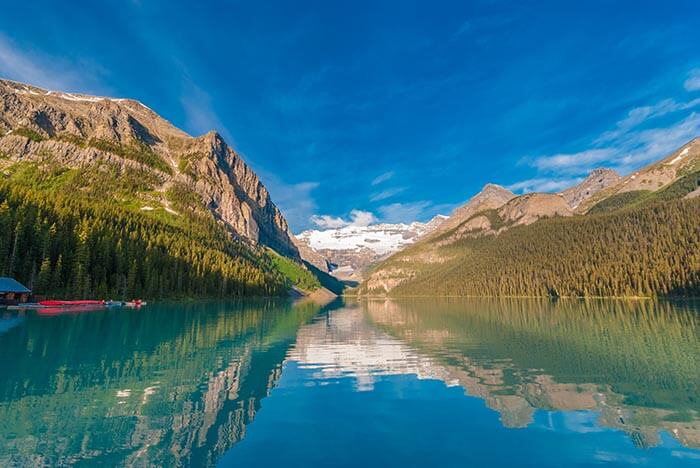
[0,158,320,298]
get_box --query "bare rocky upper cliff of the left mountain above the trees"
[0,80,299,258]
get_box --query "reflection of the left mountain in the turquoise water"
[0,302,319,466]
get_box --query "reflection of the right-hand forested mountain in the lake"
[362,300,700,448]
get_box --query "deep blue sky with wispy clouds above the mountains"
[0,0,700,232]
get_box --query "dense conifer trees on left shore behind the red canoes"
[0,181,288,298]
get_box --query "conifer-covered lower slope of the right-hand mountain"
[364,199,700,297]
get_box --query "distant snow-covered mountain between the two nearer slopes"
[296,215,446,281]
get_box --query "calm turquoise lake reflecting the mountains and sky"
[0,299,700,467]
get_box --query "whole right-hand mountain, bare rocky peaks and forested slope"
[360,139,700,297]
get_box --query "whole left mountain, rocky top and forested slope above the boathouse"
[0,80,320,297]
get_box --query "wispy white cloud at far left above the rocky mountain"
[0,34,109,94]
